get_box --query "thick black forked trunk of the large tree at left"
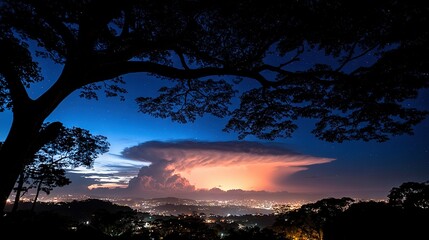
[0,65,80,213]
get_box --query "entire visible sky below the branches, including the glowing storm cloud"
[0,46,429,200]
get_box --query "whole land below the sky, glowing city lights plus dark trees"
[0,182,429,240]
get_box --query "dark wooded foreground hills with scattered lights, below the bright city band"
[0,182,429,240]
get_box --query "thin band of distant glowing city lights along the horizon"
[6,190,387,216]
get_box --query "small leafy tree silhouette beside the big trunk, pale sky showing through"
[13,123,109,210]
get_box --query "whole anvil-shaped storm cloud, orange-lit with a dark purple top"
[122,141,334,195]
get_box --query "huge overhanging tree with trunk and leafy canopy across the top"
[0,0,429,209]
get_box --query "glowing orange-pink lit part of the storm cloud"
[170,150,333,191]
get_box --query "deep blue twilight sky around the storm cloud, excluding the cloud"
[0,48,429,201]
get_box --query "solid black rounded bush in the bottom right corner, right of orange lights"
[324,201,429,240]
